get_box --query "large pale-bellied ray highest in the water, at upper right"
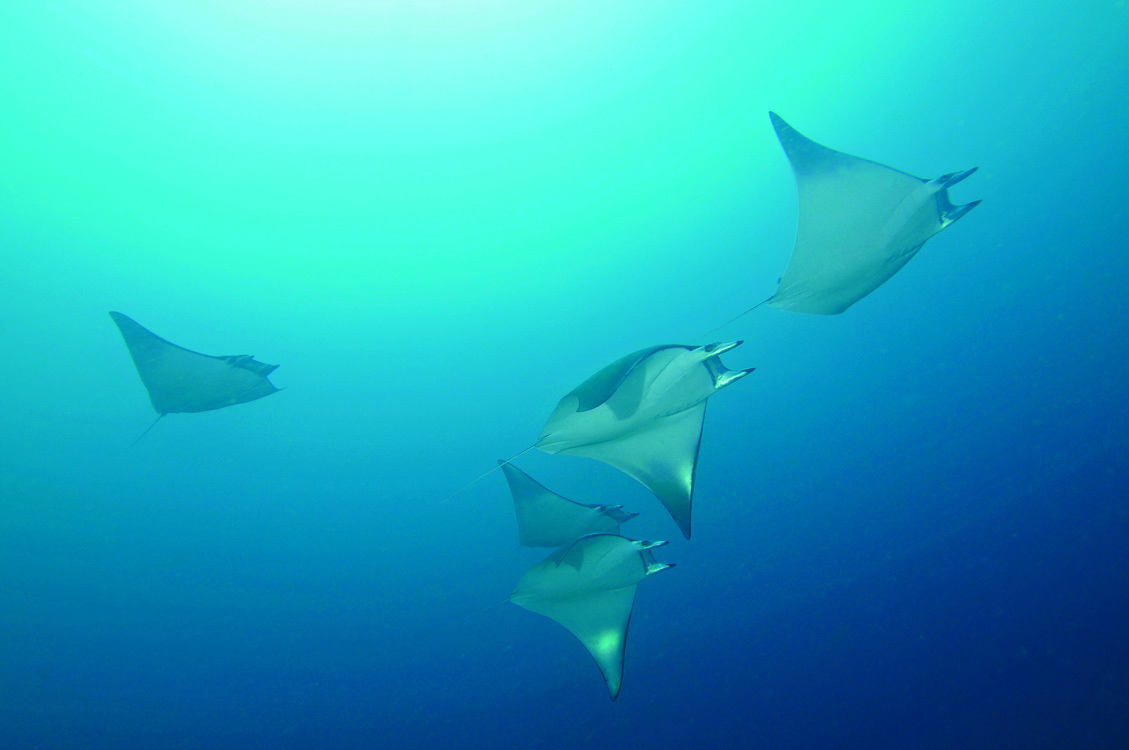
[765,112,980,315]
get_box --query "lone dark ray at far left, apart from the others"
[110,312,279,439]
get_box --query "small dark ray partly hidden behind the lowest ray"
[498,461,639,547]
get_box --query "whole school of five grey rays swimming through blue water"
[110,113,980,700]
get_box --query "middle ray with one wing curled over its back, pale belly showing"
[534,341,753,539]
